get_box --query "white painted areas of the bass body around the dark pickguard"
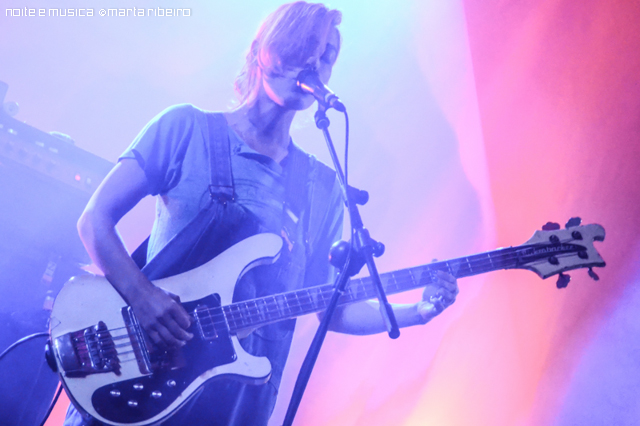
[50,234,282,426]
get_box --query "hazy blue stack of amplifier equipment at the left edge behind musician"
[0,82,113,426]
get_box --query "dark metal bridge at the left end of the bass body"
[53,321,120,377]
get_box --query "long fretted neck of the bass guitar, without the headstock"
[222,245,528,333]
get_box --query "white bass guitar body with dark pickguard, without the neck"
[50,234,282,425]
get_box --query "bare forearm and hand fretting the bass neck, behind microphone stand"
[329,272,458,335]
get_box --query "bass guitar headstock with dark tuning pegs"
[517,218,606,288]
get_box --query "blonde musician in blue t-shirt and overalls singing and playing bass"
[65,2,458,426]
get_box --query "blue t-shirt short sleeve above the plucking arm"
[118,104,196,195]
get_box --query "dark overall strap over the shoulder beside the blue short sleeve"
[207,113,235,204]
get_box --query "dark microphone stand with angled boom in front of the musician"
[283,102,400,426]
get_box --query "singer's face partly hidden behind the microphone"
[262,27,340,110]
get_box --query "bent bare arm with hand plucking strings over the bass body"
[78,159,192,347]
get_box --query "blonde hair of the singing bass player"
[235,1,342,103]
